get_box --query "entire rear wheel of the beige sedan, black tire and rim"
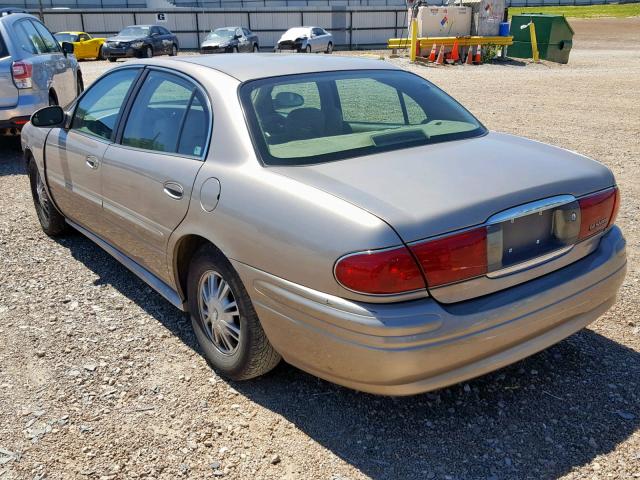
[187,245,280,380]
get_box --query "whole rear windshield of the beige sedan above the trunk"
[240,70,486,165]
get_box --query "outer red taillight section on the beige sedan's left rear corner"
[335,247,426,295]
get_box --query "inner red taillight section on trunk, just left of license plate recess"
[410,227,487,287]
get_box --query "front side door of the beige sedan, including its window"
[45,68,141,234]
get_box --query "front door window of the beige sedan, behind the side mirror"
[71,69,138,140]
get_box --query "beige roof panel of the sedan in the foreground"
[172,53,398,82]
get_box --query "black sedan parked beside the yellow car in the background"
[102,25,178,62]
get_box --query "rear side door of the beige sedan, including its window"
[102,68,211,279]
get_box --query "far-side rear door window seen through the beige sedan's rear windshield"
[336,78,404,125]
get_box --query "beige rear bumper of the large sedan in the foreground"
[234,226,626,395]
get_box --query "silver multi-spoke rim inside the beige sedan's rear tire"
[198,270,241,355]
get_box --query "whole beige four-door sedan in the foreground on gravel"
[22,54,626,395]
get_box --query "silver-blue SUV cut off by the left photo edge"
[0,13,83,135]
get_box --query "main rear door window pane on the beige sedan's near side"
[122,71,196,153]
